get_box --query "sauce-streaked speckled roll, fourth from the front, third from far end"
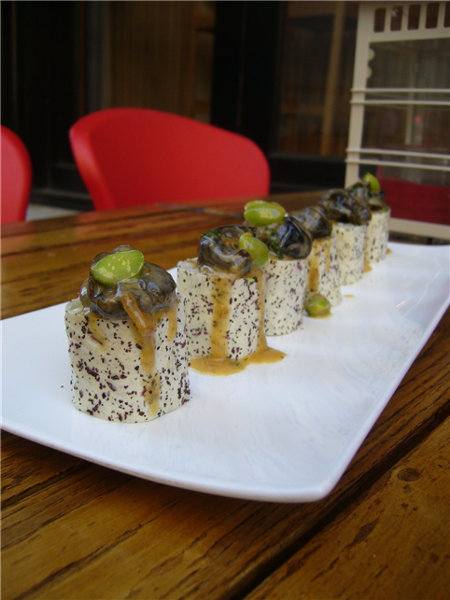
[291,206,342,306]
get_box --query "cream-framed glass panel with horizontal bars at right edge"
[346,0,450,230]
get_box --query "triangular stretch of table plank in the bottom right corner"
[247,419,450,600]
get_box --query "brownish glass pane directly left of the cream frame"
[276,0,357,157]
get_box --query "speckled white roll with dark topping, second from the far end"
[319,189,372,285]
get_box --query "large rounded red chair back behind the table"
[69,108,270,210]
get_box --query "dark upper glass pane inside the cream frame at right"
[363,38,450,153]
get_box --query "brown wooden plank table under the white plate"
[1,194,450,600]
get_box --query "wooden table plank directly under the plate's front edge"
[2,312,450,600]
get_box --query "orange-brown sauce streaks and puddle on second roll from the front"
[190,268,286,376]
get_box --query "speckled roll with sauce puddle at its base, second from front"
[177,225,284,375]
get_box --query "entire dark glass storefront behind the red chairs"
[0,0,357,210]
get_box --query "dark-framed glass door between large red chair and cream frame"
[212,0,358,192]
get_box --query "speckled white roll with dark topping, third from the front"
[253,213,312,335]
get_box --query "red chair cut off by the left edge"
[0,125,32,225]
